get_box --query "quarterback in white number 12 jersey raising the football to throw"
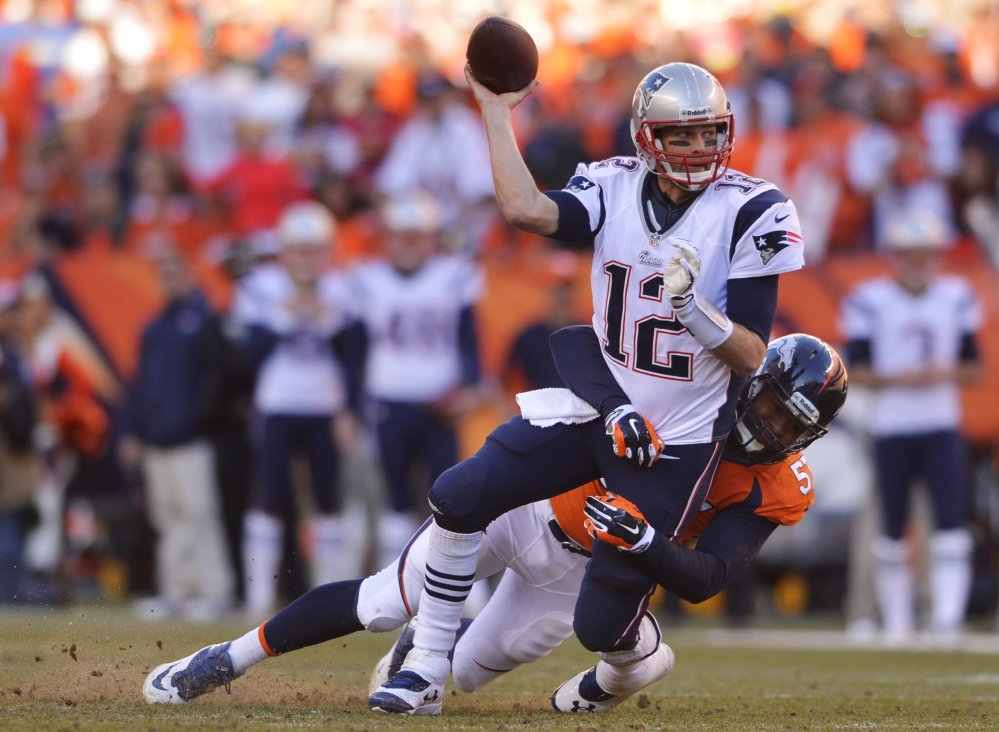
[368,63,803,714]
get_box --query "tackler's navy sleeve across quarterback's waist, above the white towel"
[548,325,631,418]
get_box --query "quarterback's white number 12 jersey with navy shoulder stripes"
[566,157,804,444]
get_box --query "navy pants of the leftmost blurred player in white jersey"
[257,414,340,516]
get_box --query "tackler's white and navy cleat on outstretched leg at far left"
[142,643,243,704]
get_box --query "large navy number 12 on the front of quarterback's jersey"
[604,262,694,381]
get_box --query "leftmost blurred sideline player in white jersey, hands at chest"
[232,202,358,618]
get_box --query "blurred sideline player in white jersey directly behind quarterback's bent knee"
[351,190,482,567]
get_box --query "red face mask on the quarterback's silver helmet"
[635,114,734,191]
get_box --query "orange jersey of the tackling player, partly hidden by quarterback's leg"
[551,453,815,551]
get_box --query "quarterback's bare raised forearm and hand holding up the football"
[465,66,559,236]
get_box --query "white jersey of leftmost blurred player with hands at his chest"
[232,264,350,415]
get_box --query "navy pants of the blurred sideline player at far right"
[874,430,964,539]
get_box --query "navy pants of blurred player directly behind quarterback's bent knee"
[375,402,458,511]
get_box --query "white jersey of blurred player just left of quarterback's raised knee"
[352,255,482,403]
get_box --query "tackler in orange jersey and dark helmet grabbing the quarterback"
[143,326,847,712]
